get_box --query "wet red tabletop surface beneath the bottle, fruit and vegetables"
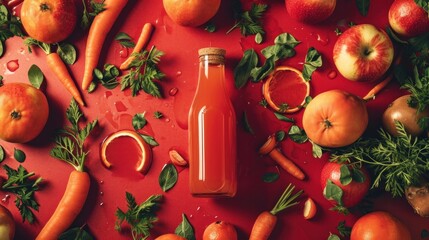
[0,0,429,240]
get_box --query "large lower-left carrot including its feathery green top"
[36,100,97,240]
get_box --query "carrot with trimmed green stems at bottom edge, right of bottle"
[249,184,302,240]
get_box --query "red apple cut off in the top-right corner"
[389,0,429,38]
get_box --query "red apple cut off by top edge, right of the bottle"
[285,0,337,23]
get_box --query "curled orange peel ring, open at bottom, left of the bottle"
[101,130,152,174]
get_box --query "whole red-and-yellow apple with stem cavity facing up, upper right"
[333,24,394,82]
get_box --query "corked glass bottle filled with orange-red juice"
[188,48,237,197]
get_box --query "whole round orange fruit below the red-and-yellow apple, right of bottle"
[302,90,368,147]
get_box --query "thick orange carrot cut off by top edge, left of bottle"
[82,0,128,90]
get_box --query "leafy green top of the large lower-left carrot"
[51,99,98,171]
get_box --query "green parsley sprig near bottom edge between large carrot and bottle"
[115,192,162,240]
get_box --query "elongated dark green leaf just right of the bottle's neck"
[234,49,259,89]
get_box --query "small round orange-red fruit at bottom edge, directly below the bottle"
[203,221,237,240]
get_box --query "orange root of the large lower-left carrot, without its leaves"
[36,170,90,240]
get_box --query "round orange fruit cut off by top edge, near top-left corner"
[21,0,77,43]
